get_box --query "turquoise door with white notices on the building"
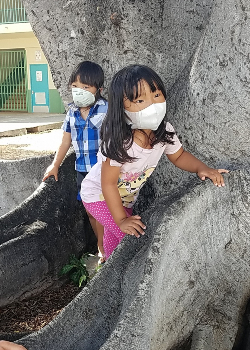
[30,64,49,113]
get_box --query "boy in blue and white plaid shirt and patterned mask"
[43,61,108,263]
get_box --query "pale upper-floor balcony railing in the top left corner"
[0,0,28,24]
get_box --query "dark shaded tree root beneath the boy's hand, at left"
[0,154,96,307]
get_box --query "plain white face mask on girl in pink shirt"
[125,101,166,130]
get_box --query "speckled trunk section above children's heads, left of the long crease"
[24,0,213,100]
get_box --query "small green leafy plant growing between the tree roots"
[59,254,89,287]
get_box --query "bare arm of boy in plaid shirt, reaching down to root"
[43,131,71,181]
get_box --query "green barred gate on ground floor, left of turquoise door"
[0,50,27,111]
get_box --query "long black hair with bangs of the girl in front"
[101,64,174,164]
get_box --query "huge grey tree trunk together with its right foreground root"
[10,0,250,350]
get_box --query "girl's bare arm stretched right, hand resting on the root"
[167,147,229,187]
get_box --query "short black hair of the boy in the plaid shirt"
[69,61,104,101]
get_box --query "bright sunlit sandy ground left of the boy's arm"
[0,129,63,160]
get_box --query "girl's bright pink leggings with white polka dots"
[83,201,132,259]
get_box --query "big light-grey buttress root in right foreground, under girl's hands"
[15,171,250,350]
